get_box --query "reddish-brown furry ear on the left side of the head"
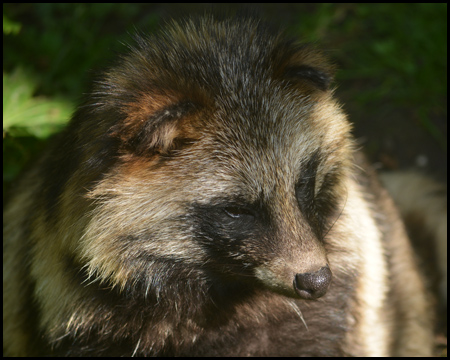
[112,95,198,155]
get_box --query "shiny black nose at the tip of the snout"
[294,265,332,300]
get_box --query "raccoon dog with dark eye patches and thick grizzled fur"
[3,17,432,356]
